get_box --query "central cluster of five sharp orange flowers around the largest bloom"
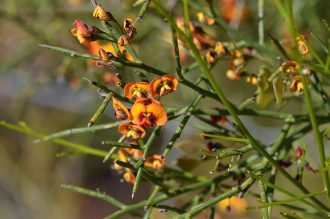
[112,75,178,139]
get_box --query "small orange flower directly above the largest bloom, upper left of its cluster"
[124,82,149,99]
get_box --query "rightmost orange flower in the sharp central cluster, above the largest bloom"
[149,75,179,97]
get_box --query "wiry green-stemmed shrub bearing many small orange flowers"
[1,0,330,218]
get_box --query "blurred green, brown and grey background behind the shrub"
[0,0,330,219]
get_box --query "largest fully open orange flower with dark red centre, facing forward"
[131,98,167,128]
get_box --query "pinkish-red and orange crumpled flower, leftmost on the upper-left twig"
[71,19,98,46]
